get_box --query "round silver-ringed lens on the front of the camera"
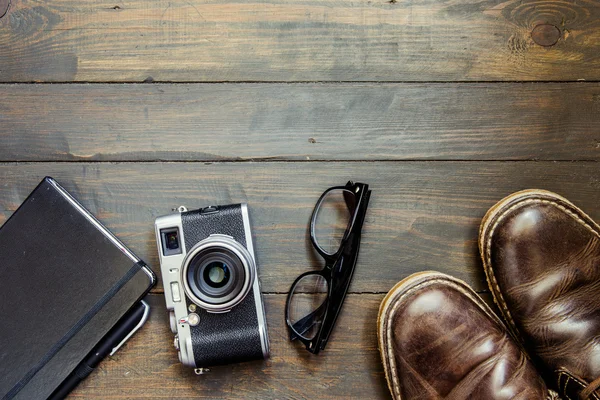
[181,234,256,313]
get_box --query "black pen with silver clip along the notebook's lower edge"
[48,300,150,400]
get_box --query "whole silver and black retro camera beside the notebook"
[155,204,269,373]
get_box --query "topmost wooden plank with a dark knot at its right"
[0,0,600,82]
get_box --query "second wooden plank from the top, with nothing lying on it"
[0,83,600,161]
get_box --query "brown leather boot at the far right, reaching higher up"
[479,190,600,400]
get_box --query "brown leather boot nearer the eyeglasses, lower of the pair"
[378,272,548,400]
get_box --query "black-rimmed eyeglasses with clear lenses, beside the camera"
[285,181,371,354]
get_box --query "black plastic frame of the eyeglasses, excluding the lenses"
[285,181,371,354]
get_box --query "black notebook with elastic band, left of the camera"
[0,178,155,400]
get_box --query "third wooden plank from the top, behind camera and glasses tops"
[0,162,600,293]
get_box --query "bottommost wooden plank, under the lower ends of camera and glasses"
[69,294,389,399]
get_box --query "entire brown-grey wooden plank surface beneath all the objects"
[0,0,600,399]
